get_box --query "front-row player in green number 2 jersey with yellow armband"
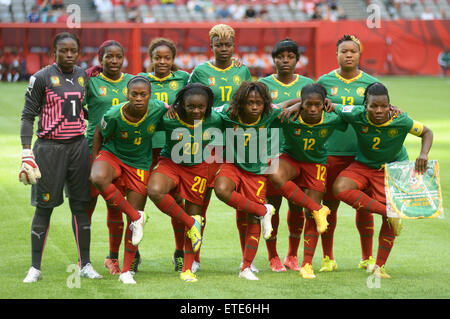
[333,83,433,278]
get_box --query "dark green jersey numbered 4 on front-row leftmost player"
[100,100,167,171]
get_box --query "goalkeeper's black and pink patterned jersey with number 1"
[21,63,87,144]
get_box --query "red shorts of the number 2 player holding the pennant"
[339,162,386,203]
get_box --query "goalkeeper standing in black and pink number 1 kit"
[19,32,102,283]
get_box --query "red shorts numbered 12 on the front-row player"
[280,154,327,193]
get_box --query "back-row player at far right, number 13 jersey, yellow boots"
[316,35,378,271]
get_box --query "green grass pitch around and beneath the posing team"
[0,77,450,299]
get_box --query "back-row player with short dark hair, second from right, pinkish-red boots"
[260,39,314,272]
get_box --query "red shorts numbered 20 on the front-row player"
[152,157,209,206]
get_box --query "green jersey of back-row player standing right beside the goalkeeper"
[84,73,133,151]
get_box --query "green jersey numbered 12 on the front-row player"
[281,112,348,164]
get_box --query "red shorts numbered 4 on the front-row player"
[94,150,150,196]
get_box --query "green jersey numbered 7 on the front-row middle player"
[216,105,282,175]
